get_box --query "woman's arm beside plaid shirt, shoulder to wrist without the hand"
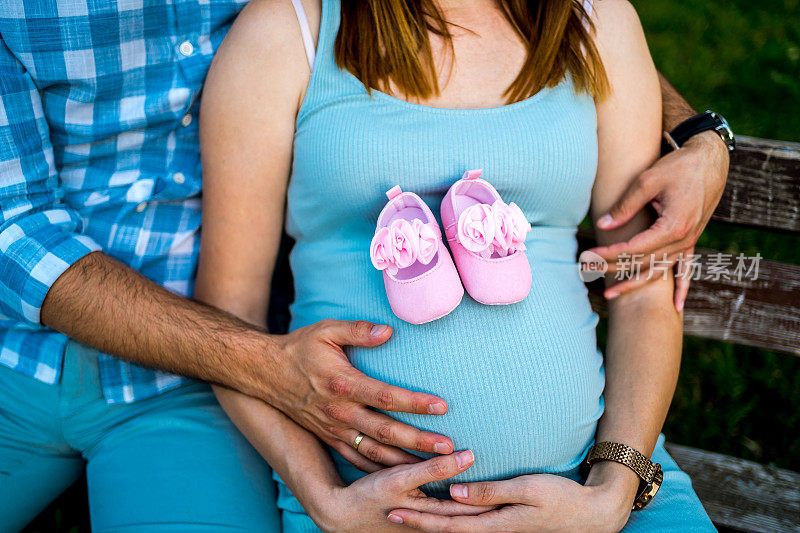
[194,1,341,520]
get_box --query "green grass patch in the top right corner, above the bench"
[636,0,800,141]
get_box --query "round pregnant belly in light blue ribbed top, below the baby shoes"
[337,272,604,495]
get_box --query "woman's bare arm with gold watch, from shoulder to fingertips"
[392,0,681,532]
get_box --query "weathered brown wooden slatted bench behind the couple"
[581,137,800,533]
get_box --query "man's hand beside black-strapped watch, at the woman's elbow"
[591,131,729,311]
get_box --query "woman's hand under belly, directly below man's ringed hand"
[307,450,492,533]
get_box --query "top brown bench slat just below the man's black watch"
[713,136,800,231]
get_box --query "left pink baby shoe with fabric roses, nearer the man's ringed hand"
[369,185,464,324]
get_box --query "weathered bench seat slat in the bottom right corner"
[656,443,800,533]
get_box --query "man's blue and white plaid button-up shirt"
[0,0,247,403]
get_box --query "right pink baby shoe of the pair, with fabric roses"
[442,170,531,305]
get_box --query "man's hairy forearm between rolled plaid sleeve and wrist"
[41,252,275,398]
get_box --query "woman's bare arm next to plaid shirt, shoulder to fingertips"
[195,0,494,531]
